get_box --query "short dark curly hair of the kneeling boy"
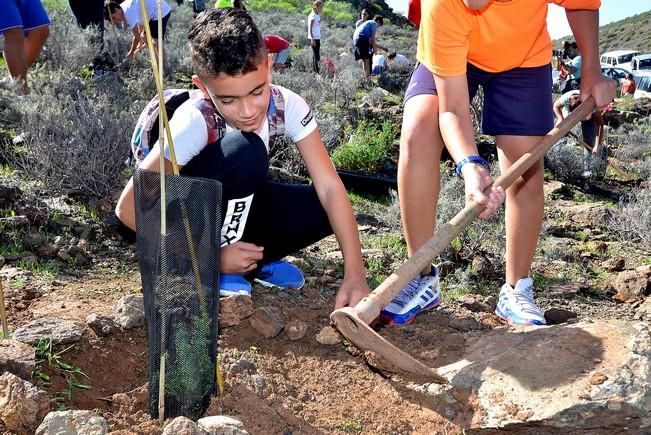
[188,8,267,77]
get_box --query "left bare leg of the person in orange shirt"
[398,95,443,274]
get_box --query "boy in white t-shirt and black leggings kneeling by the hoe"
[116,9,370,308]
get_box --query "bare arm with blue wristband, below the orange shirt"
[434,74,504,219]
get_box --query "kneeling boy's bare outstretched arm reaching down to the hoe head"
[296,129,370,309]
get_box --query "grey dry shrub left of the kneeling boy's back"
[3,72,139,197]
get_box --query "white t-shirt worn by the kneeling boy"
[165,86,317,166]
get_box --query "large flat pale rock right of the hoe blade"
[430,321,651,434]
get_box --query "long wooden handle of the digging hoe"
[354,97,595,324]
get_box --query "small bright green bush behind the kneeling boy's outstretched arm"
[332,121,397,173]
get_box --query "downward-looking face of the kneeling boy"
[192,55,272,132]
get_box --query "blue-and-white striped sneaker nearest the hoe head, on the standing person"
[380,265,441,326]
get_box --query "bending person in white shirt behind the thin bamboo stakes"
[104,0,172,61]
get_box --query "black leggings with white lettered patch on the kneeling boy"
[181,131,332,263]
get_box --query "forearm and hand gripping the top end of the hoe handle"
[565,9,616,107]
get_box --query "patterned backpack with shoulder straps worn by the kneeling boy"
[128,85,285,166]
